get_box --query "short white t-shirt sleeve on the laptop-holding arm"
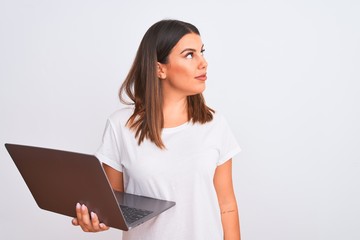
[95,119,123,172]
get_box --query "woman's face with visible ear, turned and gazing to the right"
[159,33,208,97]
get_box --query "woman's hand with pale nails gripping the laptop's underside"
[71,203,109,232]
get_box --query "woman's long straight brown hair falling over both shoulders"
[119,20,214,149]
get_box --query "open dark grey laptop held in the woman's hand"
[5,143,175,231]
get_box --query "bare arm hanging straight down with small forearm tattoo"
[214,159,240,240]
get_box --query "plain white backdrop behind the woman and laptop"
[0,0,360,240]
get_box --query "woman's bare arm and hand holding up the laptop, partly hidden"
[72,164,124,232]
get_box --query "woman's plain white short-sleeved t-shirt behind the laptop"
[96,108,240,240]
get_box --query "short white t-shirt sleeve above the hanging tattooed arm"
[217,115,241,165]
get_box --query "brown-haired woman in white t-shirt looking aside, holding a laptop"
[73,20,240,240]
